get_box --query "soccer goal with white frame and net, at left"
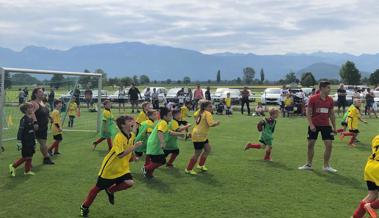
[0,67,106,152]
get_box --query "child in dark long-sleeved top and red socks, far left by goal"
[9,103,36,176]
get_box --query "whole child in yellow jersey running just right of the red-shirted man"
[340,98,367,147]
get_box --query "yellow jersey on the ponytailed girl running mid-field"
[192,111,214,142]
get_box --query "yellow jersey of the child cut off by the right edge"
[364,135,379,186]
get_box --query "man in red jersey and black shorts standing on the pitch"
[299,81,337,173]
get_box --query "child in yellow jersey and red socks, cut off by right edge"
[352,135,379,218]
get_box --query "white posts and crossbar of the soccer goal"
[0,67,103,152]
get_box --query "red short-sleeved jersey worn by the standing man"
[308,94,334,126]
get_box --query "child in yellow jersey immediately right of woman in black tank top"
[48,100,63,156]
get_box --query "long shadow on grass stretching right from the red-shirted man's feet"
[311,170,365,190]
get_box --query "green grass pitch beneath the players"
[0,109,379,218]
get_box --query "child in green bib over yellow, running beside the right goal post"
[92,100,116,151]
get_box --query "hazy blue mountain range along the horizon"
[0,42,379,81]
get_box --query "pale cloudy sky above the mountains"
[0,0,379,54]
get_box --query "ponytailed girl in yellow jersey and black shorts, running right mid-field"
[185,101,220,175]
